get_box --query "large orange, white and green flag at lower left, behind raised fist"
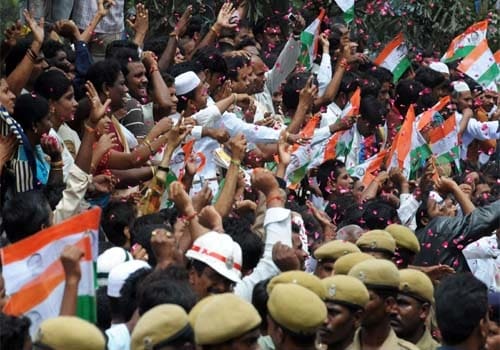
[0,208,101,334]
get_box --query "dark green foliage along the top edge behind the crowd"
[0,0,500,56]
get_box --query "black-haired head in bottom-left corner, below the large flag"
[0,313,31,350]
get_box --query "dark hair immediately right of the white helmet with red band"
[223,217,264,272]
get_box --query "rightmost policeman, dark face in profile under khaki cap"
[391,269,439,350]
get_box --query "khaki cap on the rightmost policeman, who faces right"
[399,269,434,303]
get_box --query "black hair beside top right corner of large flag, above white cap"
[101,201,137,247]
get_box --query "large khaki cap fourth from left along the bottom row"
[267,284,327,334]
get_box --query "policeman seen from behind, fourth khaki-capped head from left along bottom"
[267,283,327,350]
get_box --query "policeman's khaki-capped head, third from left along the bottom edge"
[193,293,262,350]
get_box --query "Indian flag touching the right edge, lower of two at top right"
[457,39,500,91]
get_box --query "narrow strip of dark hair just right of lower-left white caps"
[109,267,151,322]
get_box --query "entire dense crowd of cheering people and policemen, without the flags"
[0,0,500,350]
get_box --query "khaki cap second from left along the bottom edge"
[130,304,189,350]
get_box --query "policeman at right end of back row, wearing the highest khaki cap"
[385,224,420,269]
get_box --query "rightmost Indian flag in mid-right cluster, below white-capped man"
[429,113,460,165]
